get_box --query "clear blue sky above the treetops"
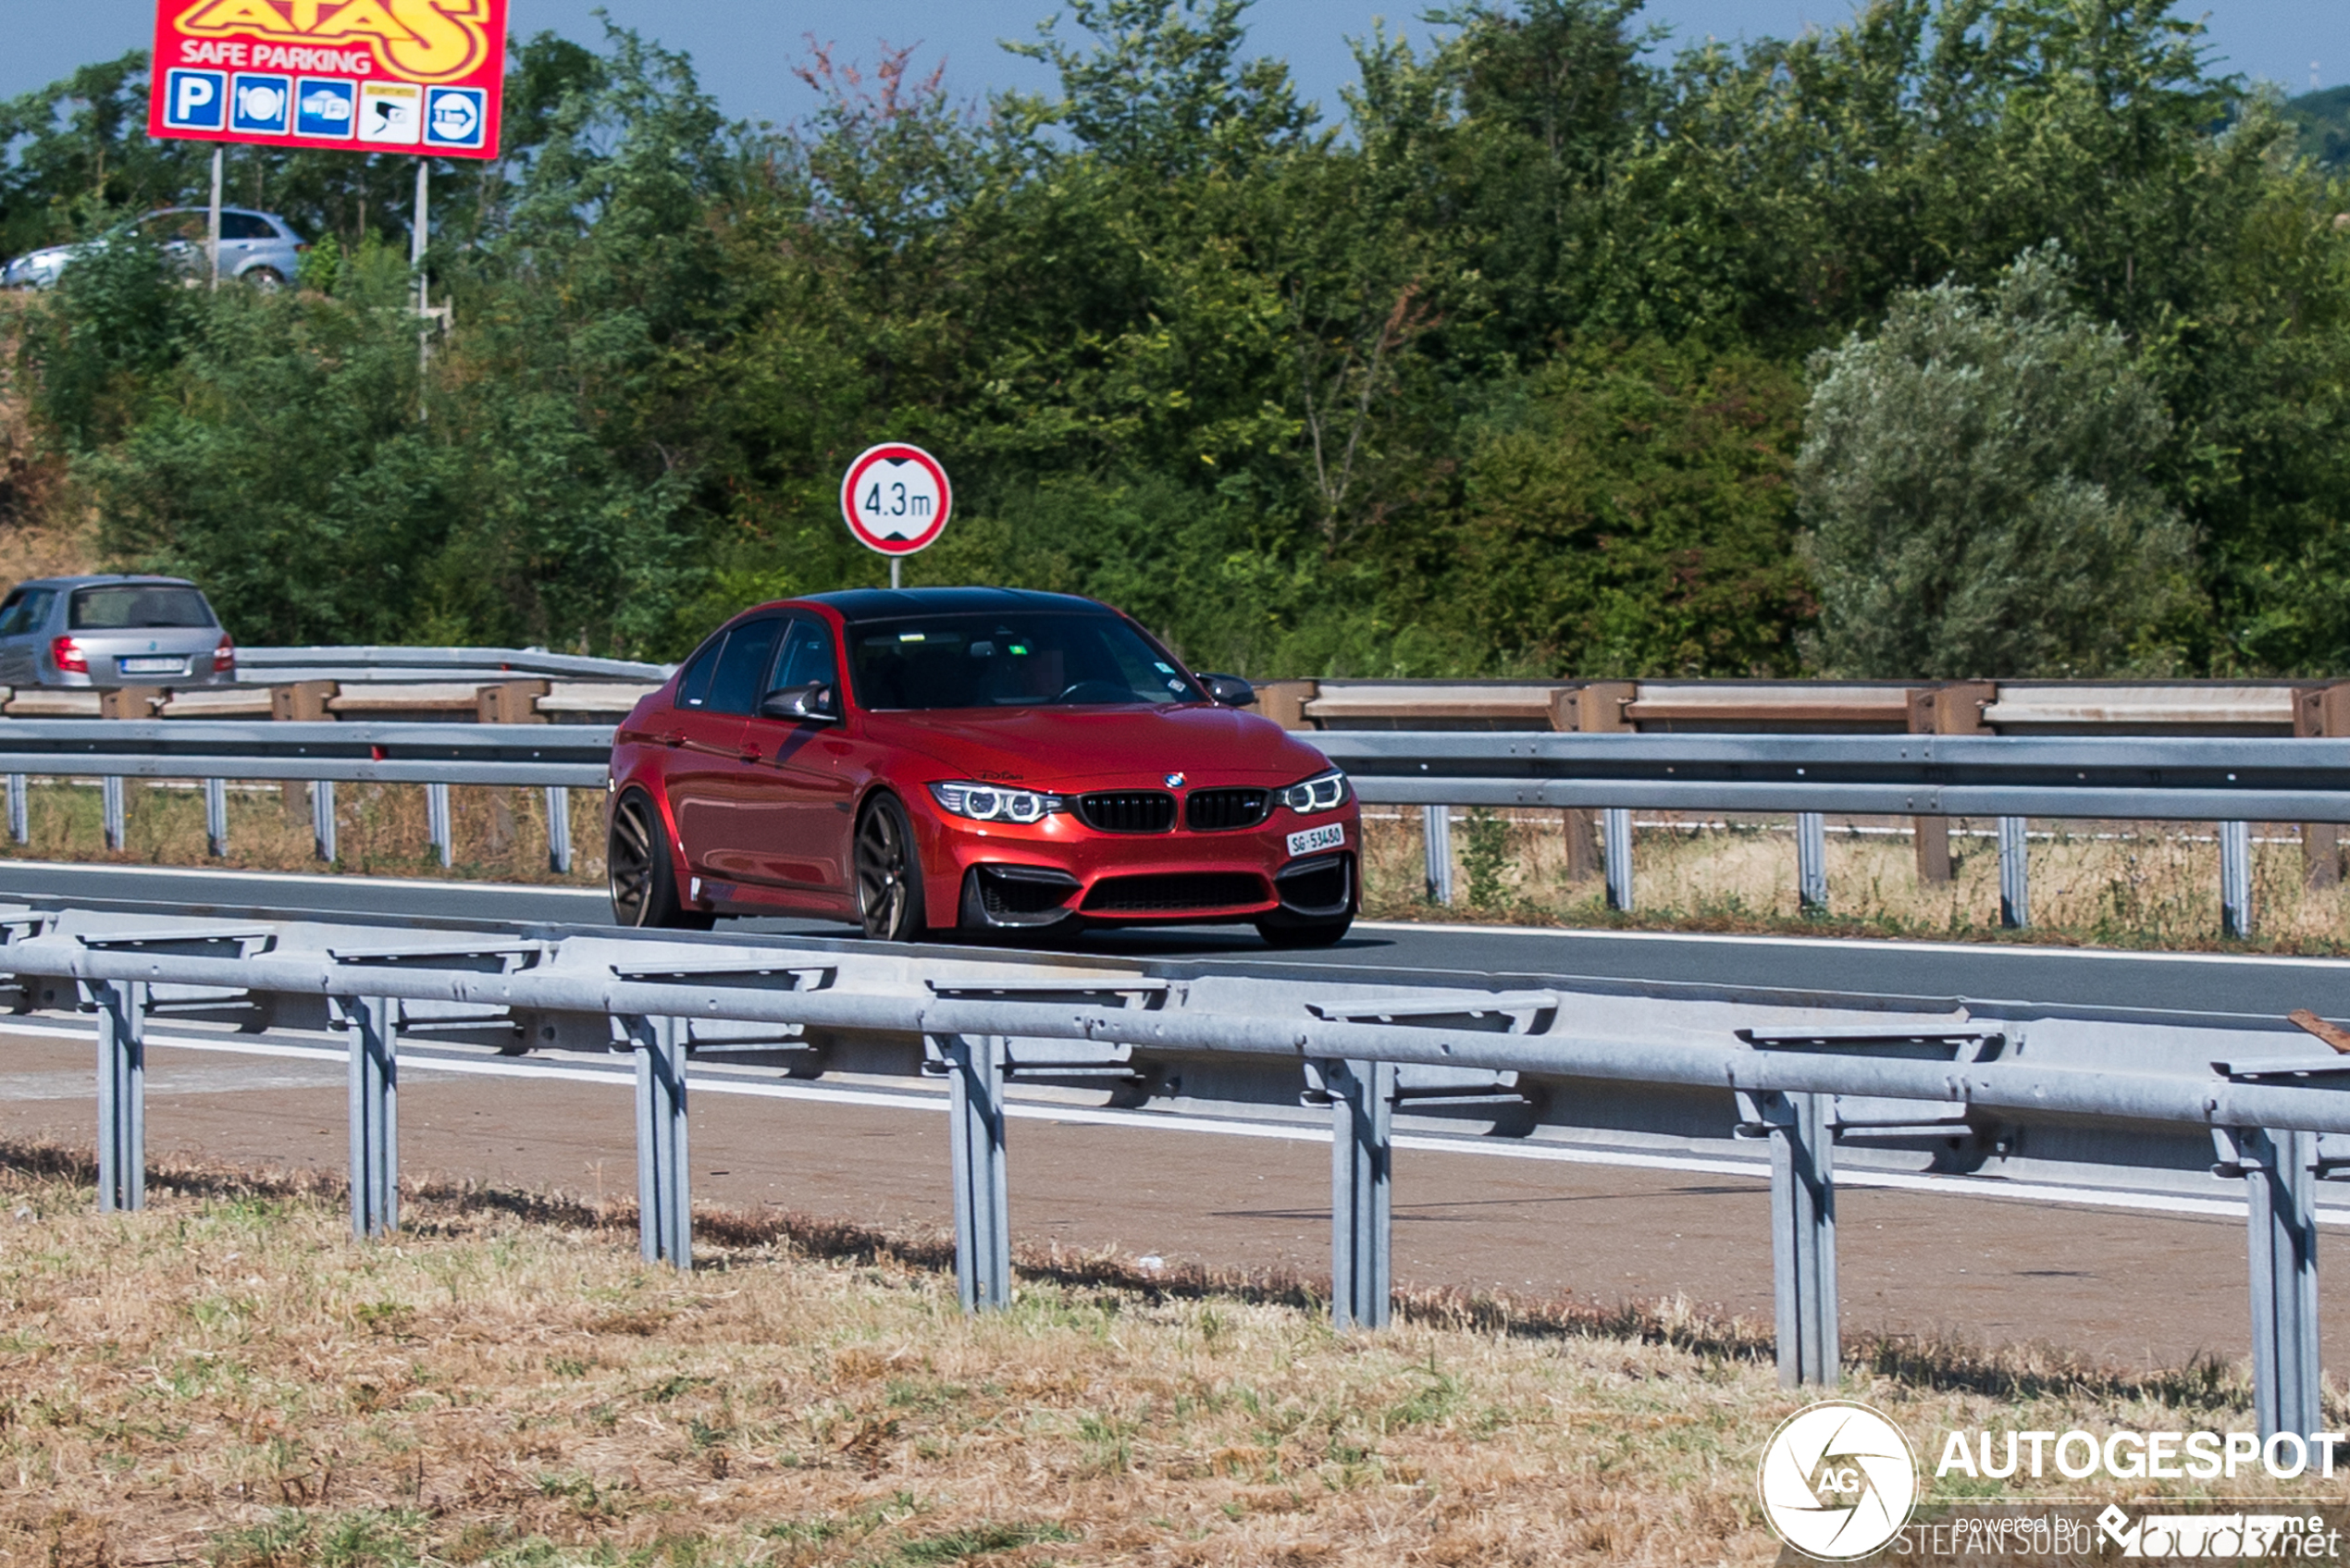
[0,0,2350,120]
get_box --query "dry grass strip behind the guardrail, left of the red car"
[0,781,604,886]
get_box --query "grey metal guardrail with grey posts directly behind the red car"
[0,720,2350,935]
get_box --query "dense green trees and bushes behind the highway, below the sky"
[0,0,2350,674]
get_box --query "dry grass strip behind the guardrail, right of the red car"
[1363,809,2350,955]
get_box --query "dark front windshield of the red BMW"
[848,611,1208,708]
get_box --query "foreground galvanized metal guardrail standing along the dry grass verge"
[13,909,2350,1434]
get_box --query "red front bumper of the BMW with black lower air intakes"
[914,804,1363,931]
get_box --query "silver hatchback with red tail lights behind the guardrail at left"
[0,576,238,686]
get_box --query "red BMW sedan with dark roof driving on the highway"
[609,587,1361,947]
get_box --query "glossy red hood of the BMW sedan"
[865,703,1330,790]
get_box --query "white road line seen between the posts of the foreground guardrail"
[0,1020,2312,1228]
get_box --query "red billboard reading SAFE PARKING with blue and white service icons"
[148,0,508,157]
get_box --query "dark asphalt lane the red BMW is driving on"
[0,860,2350,1018]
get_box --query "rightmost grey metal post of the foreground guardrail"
[2214,1126,2324,1438]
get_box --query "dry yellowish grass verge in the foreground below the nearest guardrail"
[0,1145,2310,1568]
